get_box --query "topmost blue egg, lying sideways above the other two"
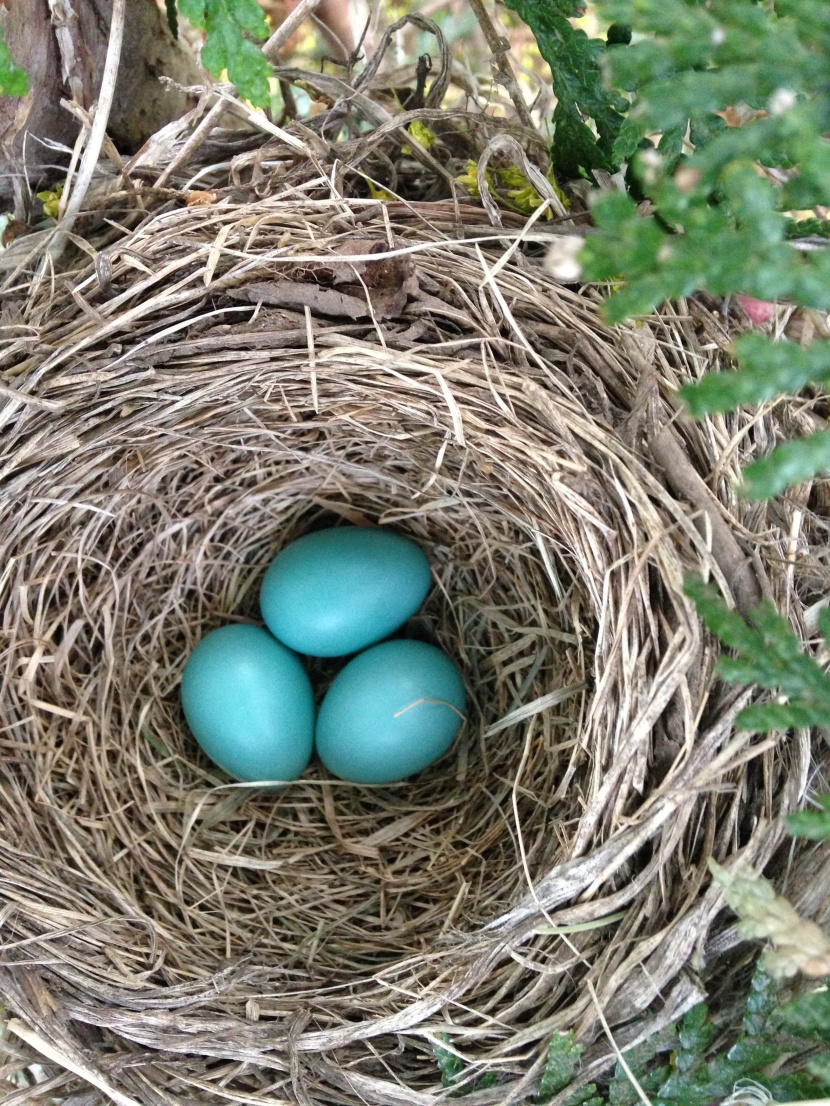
[259,526,430,657]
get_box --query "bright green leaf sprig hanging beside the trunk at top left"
[178,0,271,107]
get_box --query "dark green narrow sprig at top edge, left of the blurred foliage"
[506,0,629,176]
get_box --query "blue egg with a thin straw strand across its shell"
[314,641,465,783]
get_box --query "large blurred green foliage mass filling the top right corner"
[571,0,830,498]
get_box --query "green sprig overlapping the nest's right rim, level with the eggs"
[685,578,830,732]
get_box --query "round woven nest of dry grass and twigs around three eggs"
[0,199,810,1106]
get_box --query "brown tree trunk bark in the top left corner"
[0,0,200,207]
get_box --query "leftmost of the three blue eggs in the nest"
[181,626,314,782]
